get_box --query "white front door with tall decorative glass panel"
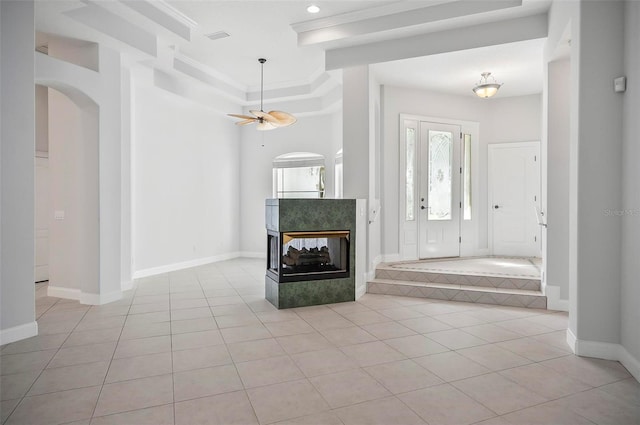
[418,122,461,258]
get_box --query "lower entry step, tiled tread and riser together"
[367,273,547,309]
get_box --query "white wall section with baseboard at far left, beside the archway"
[0,1,38,344]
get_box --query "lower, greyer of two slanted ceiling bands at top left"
[62,1,158,57]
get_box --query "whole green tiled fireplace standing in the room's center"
[265,199,356,308]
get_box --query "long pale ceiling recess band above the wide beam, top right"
[294,0,522,46]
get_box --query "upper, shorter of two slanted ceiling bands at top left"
[120,0,198,41]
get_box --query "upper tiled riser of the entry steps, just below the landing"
[376,268,540,291]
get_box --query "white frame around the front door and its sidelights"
[397,113,486,261]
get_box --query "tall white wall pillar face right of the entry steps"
[570,1,624,344]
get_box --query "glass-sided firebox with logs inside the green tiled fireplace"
[267,230,350,282]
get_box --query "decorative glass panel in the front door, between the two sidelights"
[427,130,453,220]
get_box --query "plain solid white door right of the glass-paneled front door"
[489,142,541,257]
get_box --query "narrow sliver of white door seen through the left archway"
[34,157,51,282]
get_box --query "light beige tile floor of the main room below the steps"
[0,259,640,425]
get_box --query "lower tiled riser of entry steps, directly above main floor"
[367,282,547,309]
